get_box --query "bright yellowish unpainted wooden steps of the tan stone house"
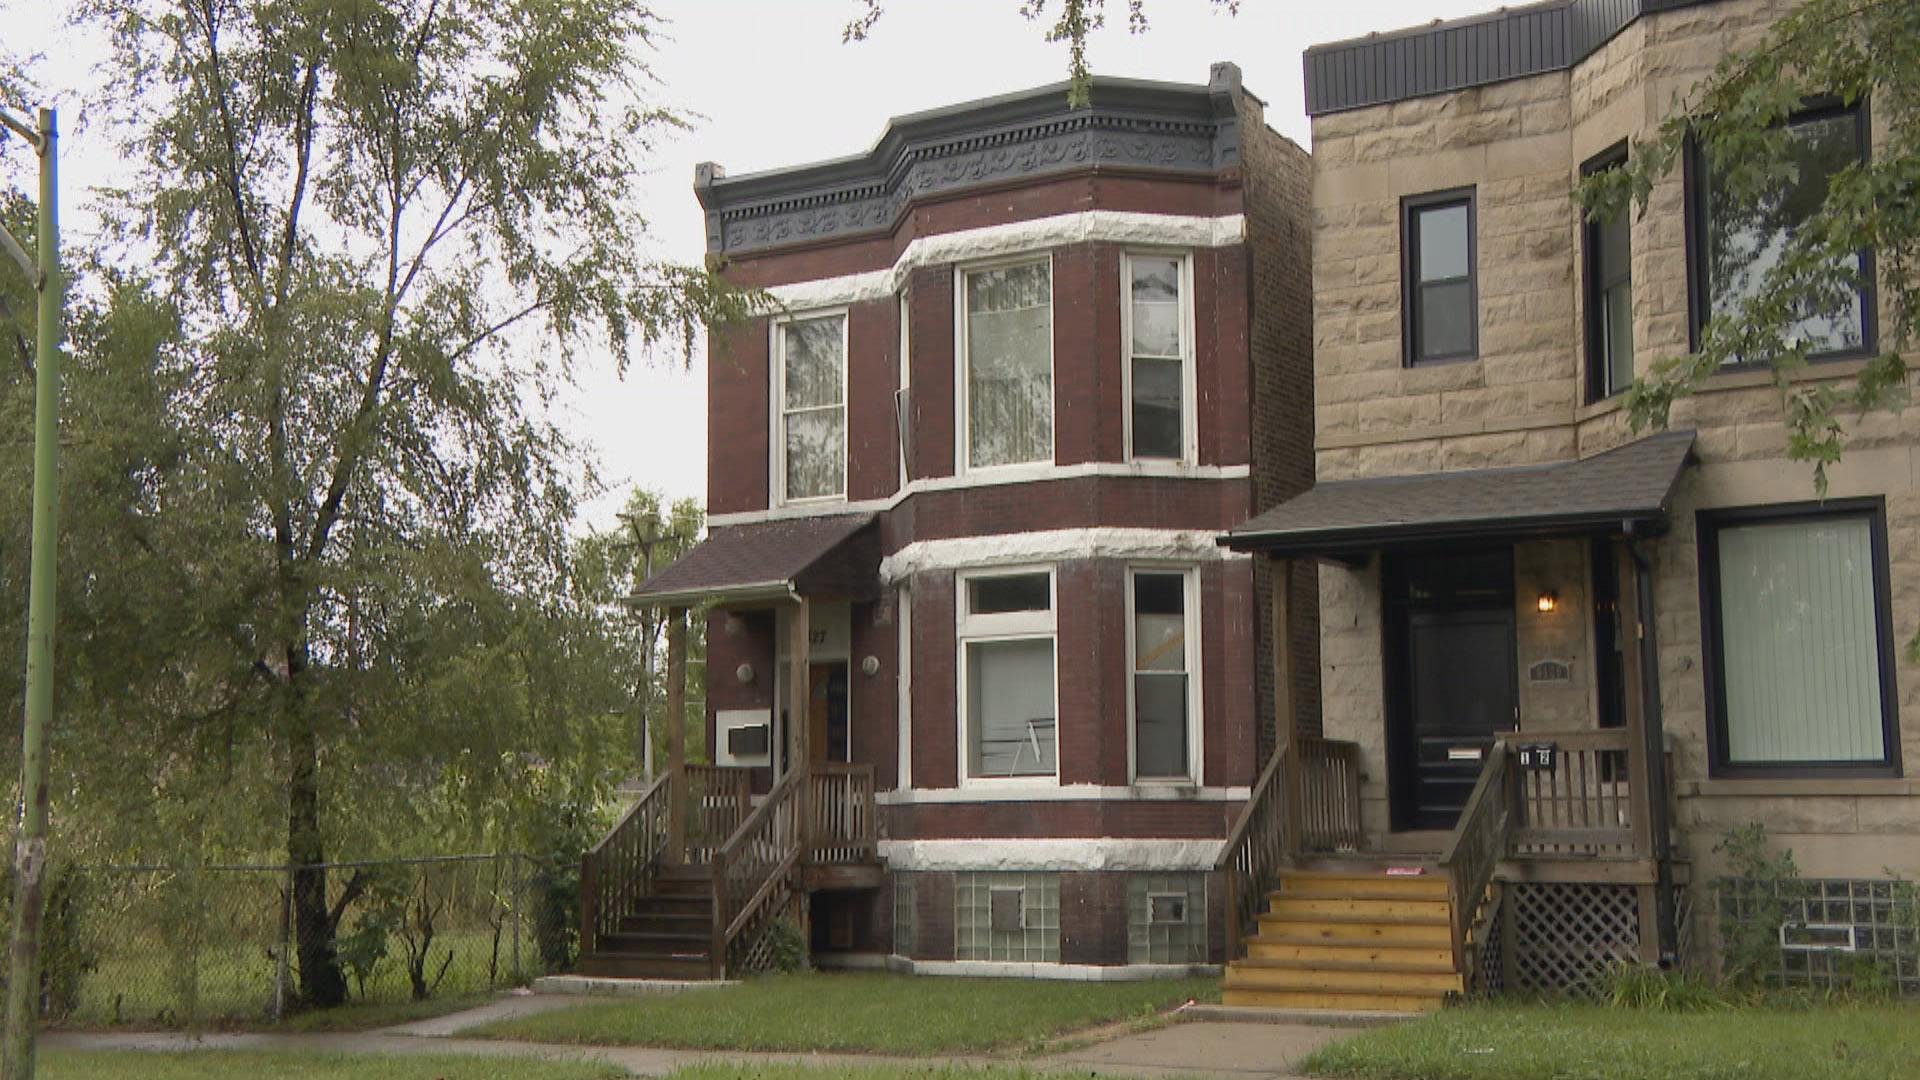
[1223,865,1463,1013]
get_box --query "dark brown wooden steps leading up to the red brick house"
[576,867,714,980]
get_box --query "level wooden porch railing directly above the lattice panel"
[1500,728,1649,857]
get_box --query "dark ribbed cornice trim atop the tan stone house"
[1304,0,1716,115]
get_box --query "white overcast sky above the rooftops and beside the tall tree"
[0,0,1498,527]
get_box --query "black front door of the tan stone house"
[1386,550,1519,830]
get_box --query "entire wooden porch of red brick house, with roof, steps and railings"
[580,517,885,980]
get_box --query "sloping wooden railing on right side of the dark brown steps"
[708,773,808,978]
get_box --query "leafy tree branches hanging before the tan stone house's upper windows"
[1576,0,1920,661]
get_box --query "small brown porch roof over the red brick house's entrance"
[628,513,879,607]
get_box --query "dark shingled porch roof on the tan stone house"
[1221,430,1693,557]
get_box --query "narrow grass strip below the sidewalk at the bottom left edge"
[36,1049,628,1080]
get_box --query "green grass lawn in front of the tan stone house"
[1304,1005,1920,1080]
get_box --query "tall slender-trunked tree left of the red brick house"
[50,0,755,1005]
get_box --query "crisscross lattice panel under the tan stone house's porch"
[1501,882,1640,997]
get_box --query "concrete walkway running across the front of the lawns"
[40,994,1346,1080]
